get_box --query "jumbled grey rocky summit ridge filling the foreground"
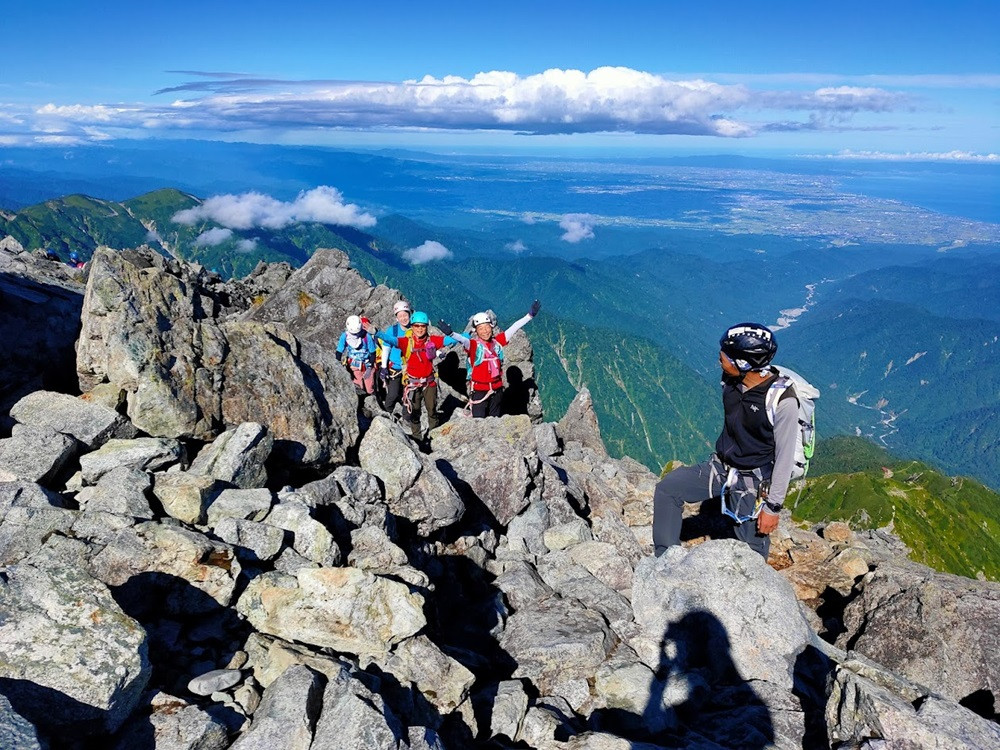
[0,242,1000,750]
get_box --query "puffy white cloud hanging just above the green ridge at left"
[173,185,375,229]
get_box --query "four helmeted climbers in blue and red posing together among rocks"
[337,300,541,438]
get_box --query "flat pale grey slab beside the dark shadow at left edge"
[10,391,137,450]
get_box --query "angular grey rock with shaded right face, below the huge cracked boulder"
[188,422,274,489]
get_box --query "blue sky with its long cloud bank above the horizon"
[0,0,1000,160]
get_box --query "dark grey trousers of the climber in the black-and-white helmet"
[653,456,771,560]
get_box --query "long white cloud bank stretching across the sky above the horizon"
[0,67,936,146]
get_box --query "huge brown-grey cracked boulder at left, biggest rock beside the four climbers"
[77,250,358,467]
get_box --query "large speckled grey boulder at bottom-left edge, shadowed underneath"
[0,537,150,737]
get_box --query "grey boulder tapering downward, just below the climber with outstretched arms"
[431,415,541,526]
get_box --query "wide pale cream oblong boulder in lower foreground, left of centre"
[237,568,427,656]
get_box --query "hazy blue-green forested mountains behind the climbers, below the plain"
[0,189,1000,494]
